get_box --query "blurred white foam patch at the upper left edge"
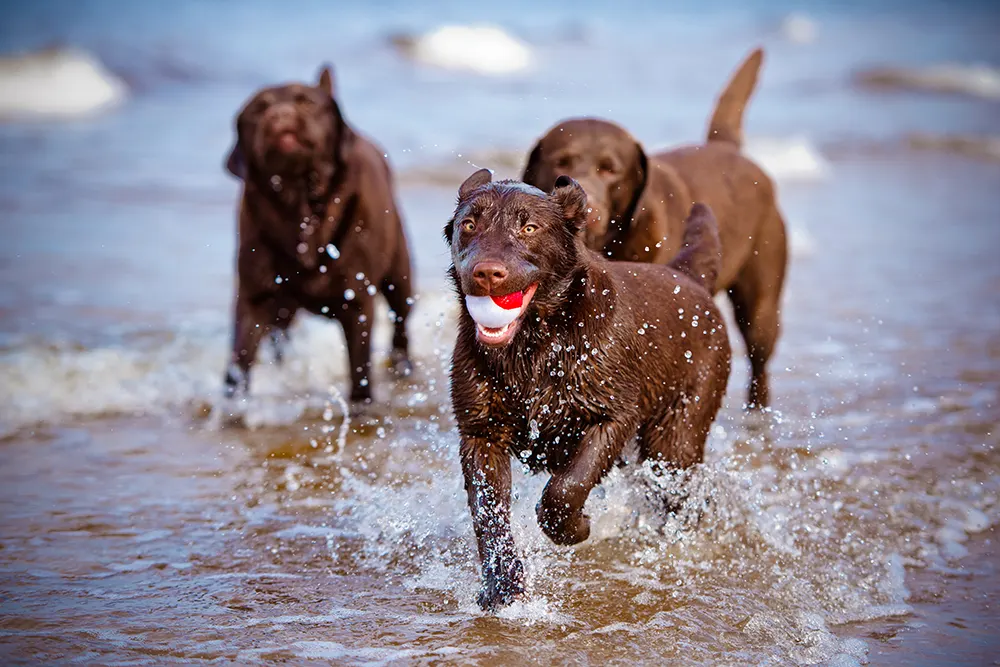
[0,49,128,117]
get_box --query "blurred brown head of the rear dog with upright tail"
[521,118,649,251]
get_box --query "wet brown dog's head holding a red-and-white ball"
[444,169,587,347]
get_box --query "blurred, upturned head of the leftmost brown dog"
[226,67,350,183]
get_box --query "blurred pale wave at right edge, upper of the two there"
[854,63,1000,100]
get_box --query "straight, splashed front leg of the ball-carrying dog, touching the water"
[461,438,524,611]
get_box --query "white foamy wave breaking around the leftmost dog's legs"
[0,290,455,437]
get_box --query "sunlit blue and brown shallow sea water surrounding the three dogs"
[0,3,1000,665]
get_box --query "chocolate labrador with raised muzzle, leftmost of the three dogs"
[225,68,413,403]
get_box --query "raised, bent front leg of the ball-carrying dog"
[536,421,636,545]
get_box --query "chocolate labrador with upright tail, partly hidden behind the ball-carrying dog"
[522,49,788,408]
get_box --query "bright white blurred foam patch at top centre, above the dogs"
[408,25,533,75]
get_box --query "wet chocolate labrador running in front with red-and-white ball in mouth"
[444,169,730,610]
